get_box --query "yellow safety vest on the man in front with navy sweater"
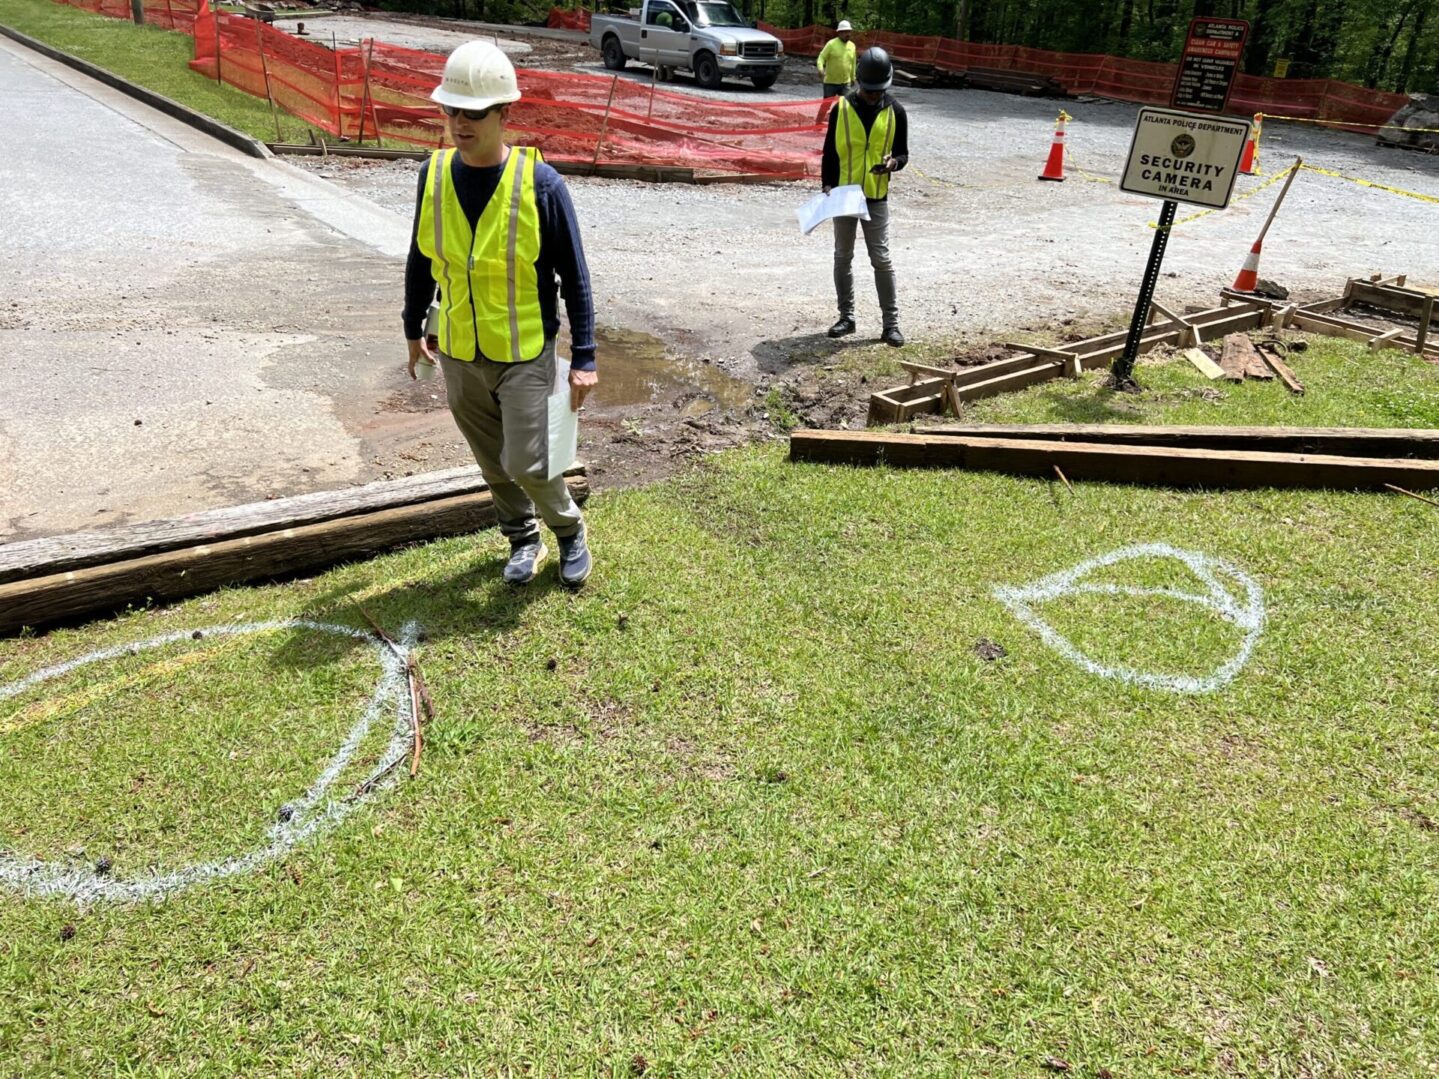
[414,147,544,364]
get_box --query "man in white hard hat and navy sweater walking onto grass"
[403,42,597,587]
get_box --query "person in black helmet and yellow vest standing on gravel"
[820,46,909,348]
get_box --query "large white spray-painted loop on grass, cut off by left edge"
[0,620,416,902]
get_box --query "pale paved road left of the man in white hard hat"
[0,39,468,541]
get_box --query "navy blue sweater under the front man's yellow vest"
[401,154,594,371]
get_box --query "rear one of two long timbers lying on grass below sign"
[914,423,1439,460]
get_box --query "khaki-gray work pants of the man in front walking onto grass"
[440,340,584,542]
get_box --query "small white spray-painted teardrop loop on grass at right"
[994,544,1265,693]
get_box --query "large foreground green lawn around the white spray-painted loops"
[0,342,1439,1076]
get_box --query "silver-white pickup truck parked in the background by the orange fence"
[590,0,784,89]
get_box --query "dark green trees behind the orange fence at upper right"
[750,0,1439,92]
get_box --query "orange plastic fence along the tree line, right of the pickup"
[761,23,1409,132]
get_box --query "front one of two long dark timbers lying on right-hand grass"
[790,430,1439,491]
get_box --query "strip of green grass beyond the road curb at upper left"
[0,0,325,142]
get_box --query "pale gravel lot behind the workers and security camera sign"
[294,46,1439,378]
